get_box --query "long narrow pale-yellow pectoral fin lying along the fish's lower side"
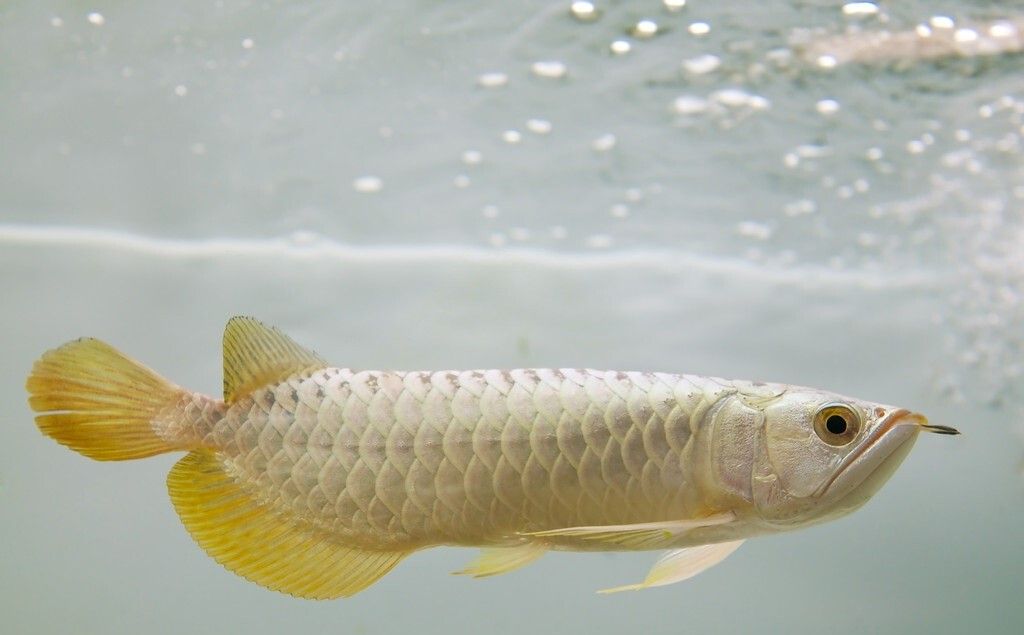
[524,512,736,549]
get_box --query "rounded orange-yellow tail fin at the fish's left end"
[26,338,185,461]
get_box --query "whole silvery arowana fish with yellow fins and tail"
[27,318,956,598]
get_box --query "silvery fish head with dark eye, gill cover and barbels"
[751,388,956,528]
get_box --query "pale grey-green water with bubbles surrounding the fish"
[0,0,1024,633]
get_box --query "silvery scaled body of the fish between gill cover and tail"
[205,368,735,548]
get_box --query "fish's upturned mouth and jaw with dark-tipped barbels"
[814,408,937,505]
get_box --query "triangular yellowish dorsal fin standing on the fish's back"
[224,316,328,404]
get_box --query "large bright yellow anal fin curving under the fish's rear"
[167,452,408,599]
